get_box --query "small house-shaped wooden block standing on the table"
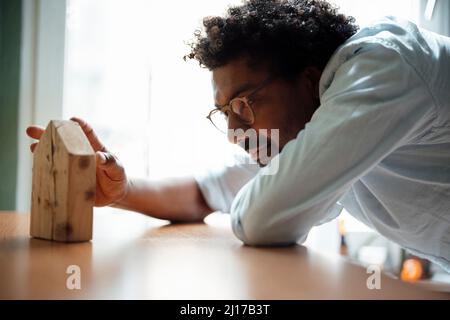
[30,120,96,242]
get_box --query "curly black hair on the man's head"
[184,0,358,78]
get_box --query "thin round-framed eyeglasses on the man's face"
[206,77,273,133]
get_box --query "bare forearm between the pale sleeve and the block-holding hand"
[112,178,213,222]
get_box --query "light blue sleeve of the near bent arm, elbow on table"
[231,44,434,245]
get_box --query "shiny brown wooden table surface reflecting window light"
[0,211,450,299]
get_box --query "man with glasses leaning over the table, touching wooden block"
[28,0,450,271]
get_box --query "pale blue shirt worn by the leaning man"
[197,17,450,272]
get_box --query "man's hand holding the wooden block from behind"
[26,118,128,207]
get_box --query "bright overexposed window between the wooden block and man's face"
[63,0,243,178]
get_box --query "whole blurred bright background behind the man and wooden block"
[0,0,450,283]
